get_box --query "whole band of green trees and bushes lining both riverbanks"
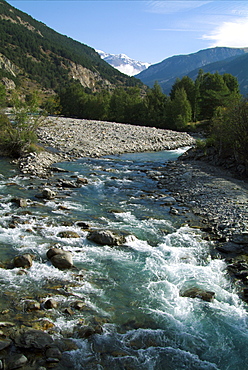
[0,70,248,173]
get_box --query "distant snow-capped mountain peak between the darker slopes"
[96,50,151,76]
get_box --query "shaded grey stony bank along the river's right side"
[149,157,248,302]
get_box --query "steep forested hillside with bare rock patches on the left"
[0,0,141,91]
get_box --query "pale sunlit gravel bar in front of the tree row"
[19,117,195,176]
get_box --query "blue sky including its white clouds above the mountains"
[7,0,248,64]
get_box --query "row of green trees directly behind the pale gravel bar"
[58,70,241,130]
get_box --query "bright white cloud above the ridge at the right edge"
[202,17,248,47]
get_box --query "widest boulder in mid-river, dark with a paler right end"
[87,230,126,246]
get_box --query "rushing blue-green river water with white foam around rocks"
[0,151,248,370]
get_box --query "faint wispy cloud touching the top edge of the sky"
[147,0,212,14]
